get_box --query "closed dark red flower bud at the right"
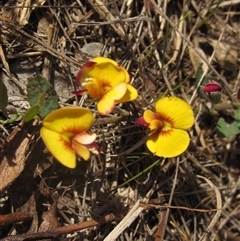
[203,81,222,104]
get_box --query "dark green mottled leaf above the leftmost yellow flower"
[27,76,59,118]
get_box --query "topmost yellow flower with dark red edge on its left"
[73,57,138,115]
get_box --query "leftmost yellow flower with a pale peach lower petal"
[40,107,99,168]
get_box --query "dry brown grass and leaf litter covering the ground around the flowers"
[0,0,240,241]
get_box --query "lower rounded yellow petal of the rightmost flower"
[147,129,190,158]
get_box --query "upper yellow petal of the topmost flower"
[84,57,130,87]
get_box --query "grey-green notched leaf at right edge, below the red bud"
[217,117,240,137]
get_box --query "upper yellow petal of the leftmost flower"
[42,107,95,137]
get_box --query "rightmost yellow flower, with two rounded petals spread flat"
[137,96,194,158]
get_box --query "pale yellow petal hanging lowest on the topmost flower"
[97,83,127,115]
